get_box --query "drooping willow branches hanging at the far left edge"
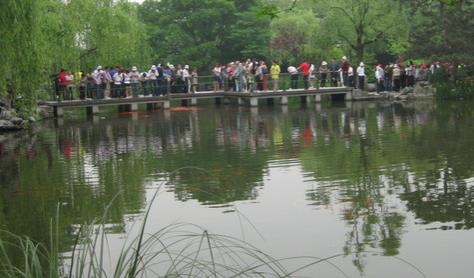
[0,0,45,115]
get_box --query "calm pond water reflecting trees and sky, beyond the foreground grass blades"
[0,102,474,278]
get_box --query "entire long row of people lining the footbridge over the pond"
[53,56,440,100]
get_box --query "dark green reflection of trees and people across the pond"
[0,100,474,276]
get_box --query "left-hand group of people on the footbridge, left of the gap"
[55,64,198,100]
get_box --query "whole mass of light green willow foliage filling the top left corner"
[0,0,149,116]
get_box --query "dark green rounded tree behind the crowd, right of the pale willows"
[139,0,270,70]
